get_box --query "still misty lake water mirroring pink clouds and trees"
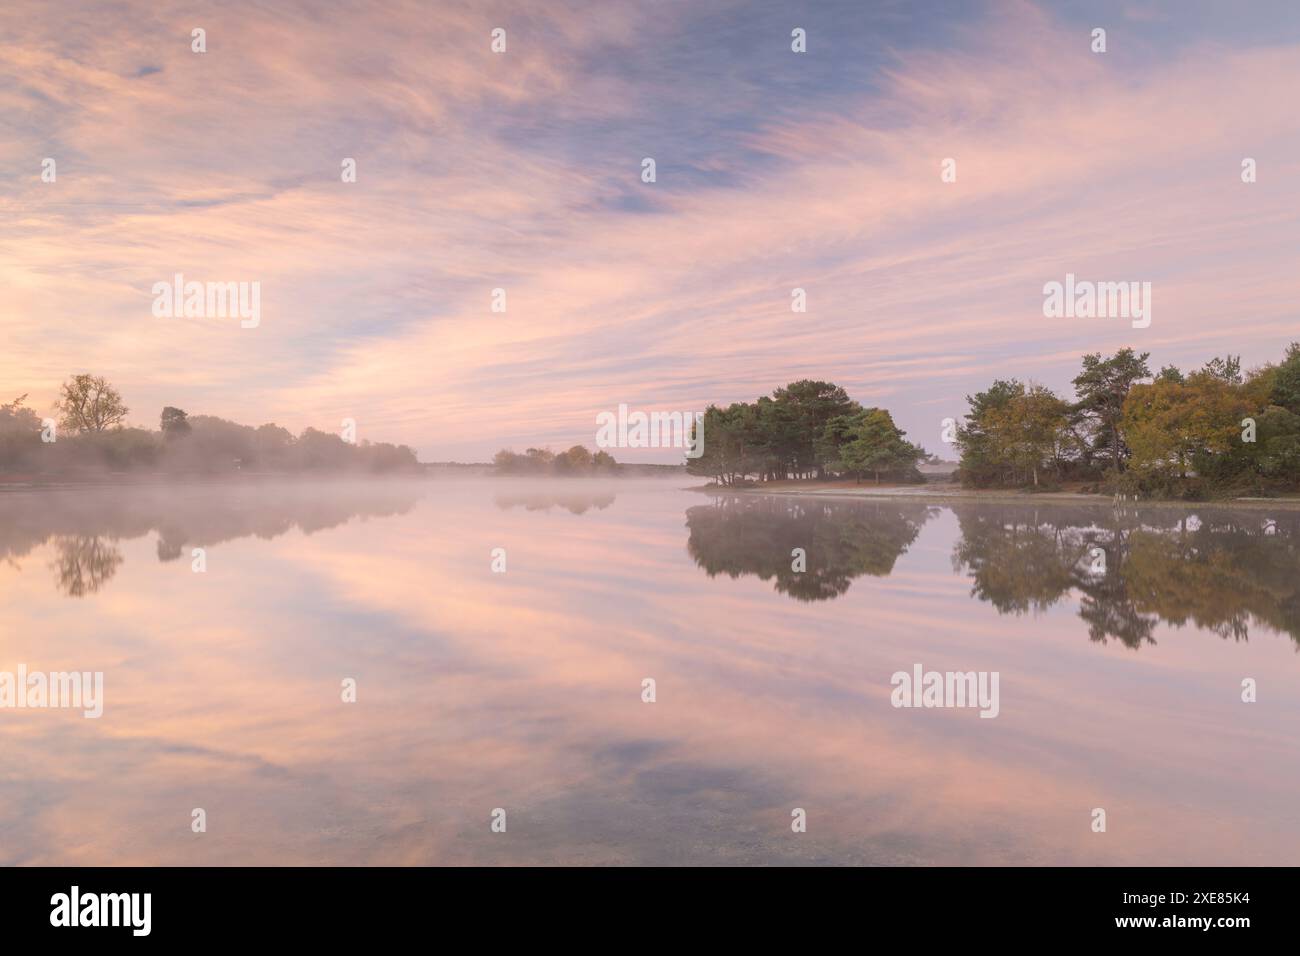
[0,480,1300,865]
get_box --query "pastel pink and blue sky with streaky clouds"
[0,0,1300,462]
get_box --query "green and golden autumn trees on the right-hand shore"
[957,342,1300,498]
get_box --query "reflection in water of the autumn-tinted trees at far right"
[953,505,1300,648]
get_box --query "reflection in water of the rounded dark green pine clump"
[686,496,939,601]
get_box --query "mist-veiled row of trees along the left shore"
[0,375,420,475]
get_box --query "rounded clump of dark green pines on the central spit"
[686,380,927,485]
